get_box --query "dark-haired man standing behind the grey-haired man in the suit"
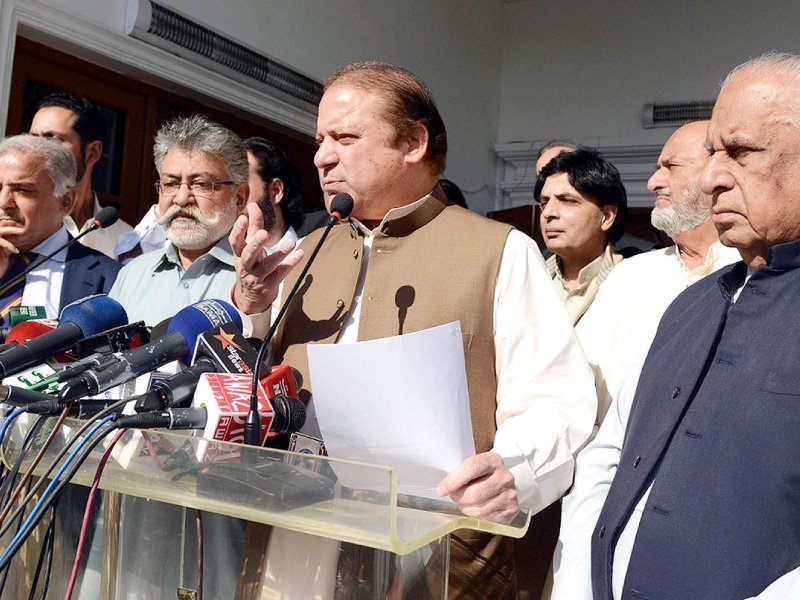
[30,92,132,258]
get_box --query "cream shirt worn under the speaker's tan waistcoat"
[273,195,597,512]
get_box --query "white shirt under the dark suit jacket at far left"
[22,225,69,319]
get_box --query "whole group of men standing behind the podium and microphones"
[0,54,800,600]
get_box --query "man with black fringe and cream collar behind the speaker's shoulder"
[533,148,628,325]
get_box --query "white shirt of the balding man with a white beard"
[552,242,741,600]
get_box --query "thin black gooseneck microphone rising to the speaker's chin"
[244,192,353,446]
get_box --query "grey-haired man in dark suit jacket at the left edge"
[0,135,120,325]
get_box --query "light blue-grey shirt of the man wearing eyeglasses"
[108,236,236,327]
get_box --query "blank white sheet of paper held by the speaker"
[304,322,475,498]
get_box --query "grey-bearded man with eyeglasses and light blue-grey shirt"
[109,115,249,326]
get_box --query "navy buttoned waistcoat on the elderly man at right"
[592,242,800,600]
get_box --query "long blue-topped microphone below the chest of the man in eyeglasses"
[59,300,242,402]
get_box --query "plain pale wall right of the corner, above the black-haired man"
[498,0,800,144]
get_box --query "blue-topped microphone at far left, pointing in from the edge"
[0,295,128,379]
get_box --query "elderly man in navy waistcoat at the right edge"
[592,53,800,600]
